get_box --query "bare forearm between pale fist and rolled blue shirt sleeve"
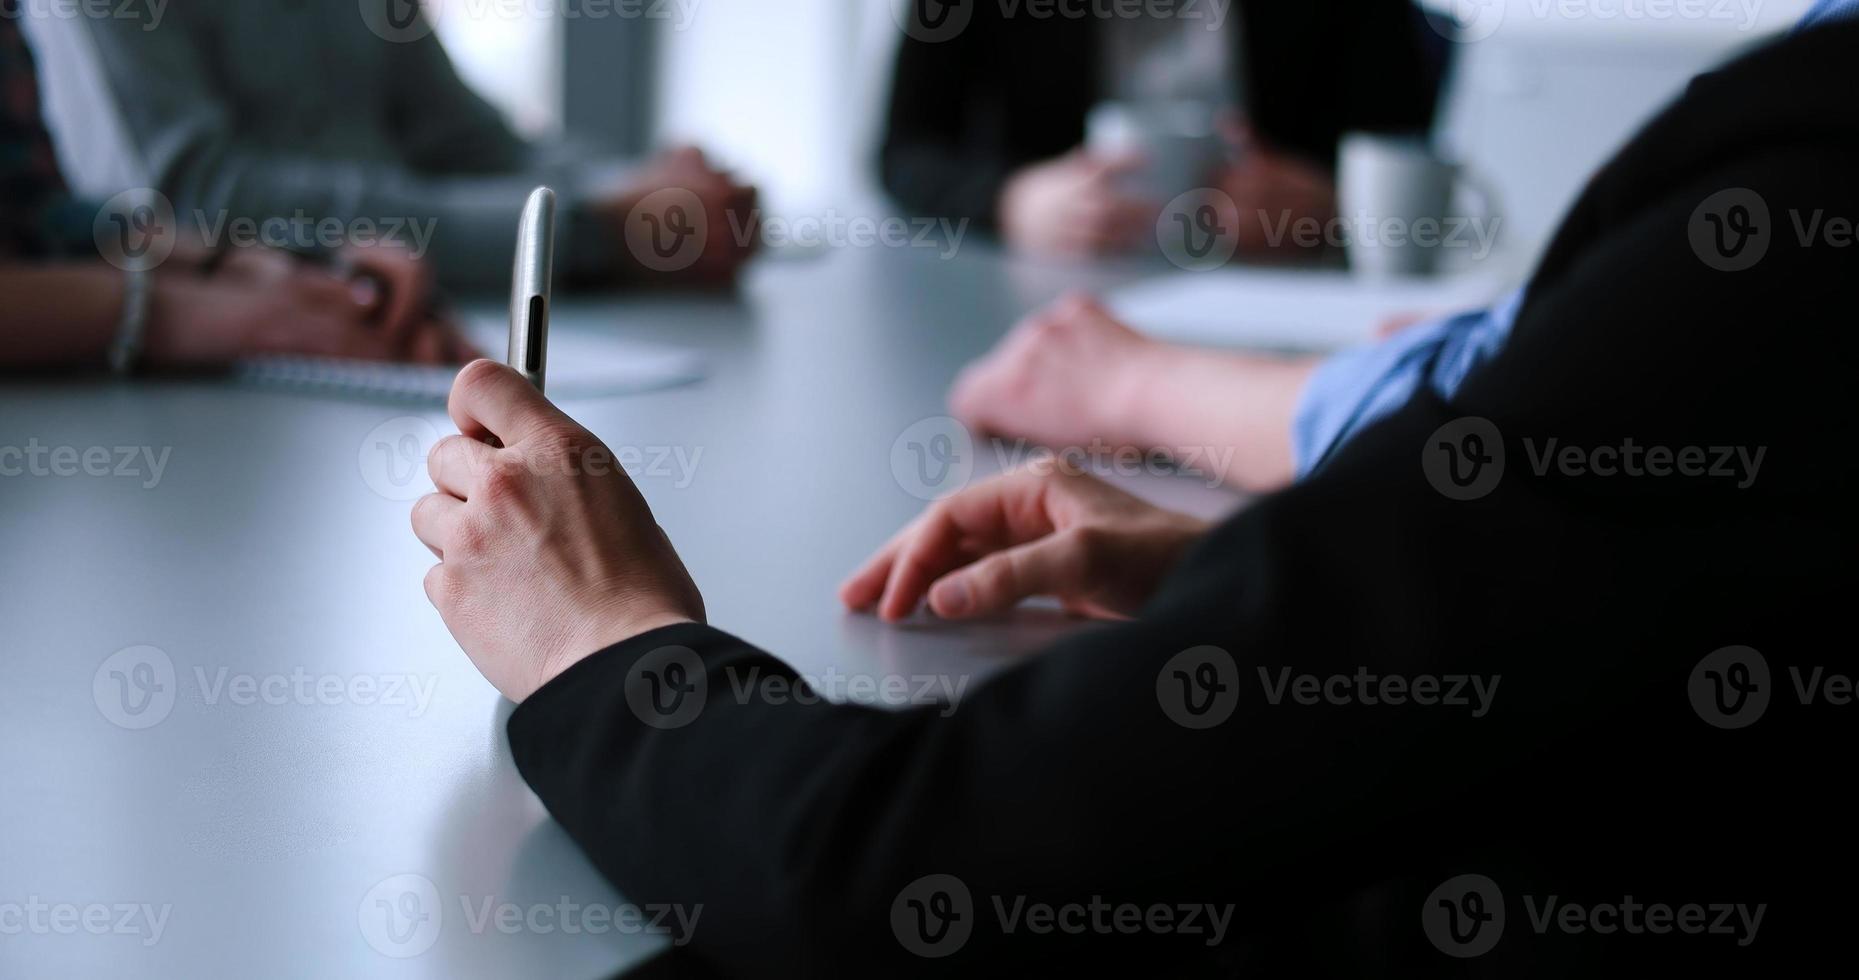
[1119,344,1318,491]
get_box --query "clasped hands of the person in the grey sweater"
[597,147,758,286]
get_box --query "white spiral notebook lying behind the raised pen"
[232,327,705,404]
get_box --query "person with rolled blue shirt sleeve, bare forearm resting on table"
[936,0,1859,493]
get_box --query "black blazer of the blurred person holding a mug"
[879,0,1444,229]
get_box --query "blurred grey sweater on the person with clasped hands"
[87,0,613,288]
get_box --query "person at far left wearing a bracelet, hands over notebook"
[0,0,464,372]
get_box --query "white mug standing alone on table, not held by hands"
[1337,134,1502,277]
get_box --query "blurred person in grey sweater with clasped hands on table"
[72,0,755,288]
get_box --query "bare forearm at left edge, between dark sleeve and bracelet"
[0,262,125,370]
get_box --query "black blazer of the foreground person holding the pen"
[509,24,1859,976]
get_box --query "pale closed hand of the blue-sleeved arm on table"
[950,294,1167,446]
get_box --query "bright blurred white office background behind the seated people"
[18,0,1811,260]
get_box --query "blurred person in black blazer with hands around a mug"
[879,0,1444,257]
